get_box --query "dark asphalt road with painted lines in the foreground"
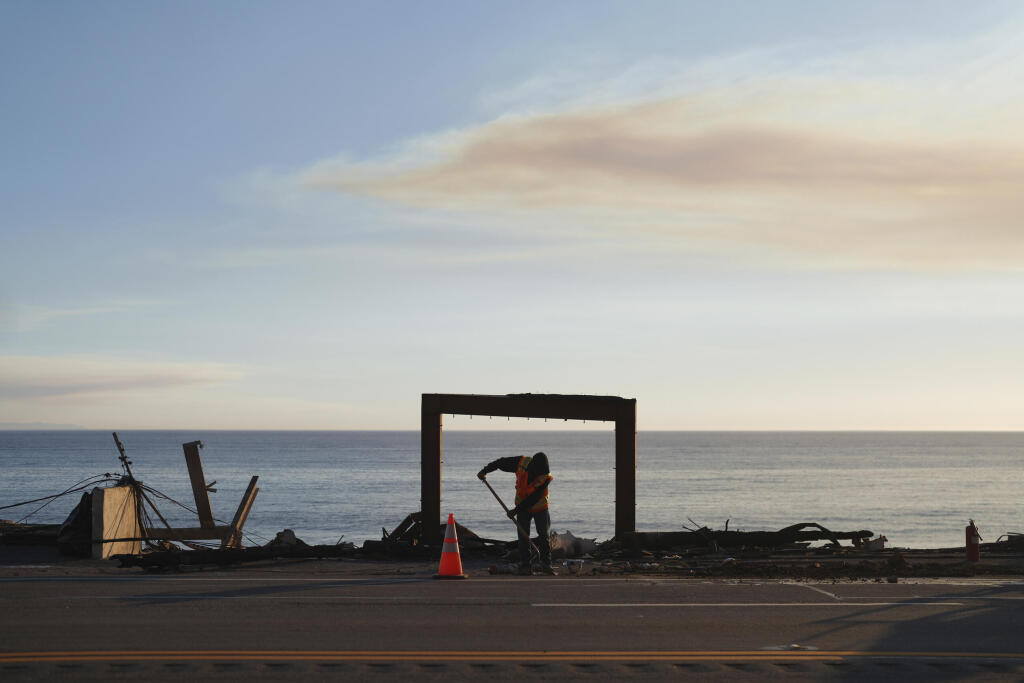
[0,565,1024,681]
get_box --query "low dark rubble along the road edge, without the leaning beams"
[6,491,1024,582]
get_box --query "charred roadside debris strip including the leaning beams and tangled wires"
[0,432,1024,579]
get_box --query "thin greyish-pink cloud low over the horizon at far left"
[0,355,243,400]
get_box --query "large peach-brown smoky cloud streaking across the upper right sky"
[301,33,1024,268]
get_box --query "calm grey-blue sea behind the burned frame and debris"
[0,430,1024,548]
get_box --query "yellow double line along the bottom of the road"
[0,650,1024,664]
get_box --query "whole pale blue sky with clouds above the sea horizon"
[0,0,1024,430]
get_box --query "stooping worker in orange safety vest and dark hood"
[476,453,555,577]
